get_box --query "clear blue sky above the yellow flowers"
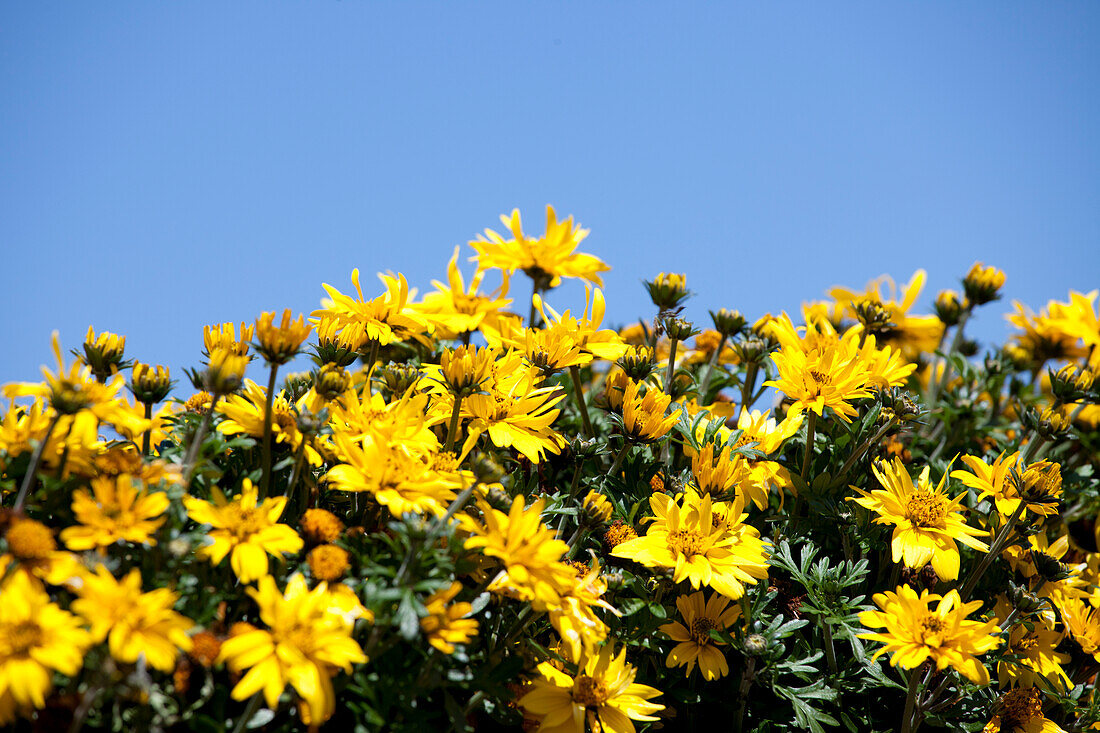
[0,0,1100,382]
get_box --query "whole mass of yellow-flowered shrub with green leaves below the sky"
[0,209,1100,733]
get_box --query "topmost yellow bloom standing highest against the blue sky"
[470,206,611,289]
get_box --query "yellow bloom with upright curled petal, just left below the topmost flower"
[416,247,512,339]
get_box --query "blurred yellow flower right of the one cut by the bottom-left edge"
[73,565,195,671]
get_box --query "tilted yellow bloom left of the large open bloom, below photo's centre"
[460,495,576,608]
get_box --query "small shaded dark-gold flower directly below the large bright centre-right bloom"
[660,591,741,680]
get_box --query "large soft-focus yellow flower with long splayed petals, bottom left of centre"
[218,575,366,724]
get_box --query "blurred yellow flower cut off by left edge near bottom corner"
[0,572,91,708]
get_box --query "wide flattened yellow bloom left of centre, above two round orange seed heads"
[325,433,461,516]
